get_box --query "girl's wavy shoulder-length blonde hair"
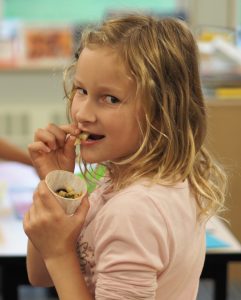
[64,15,226,215]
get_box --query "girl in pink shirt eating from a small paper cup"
[24,15,225,300]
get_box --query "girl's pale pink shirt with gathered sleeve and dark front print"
[78,180,205,300]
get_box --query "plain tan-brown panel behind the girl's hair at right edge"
[206,99,241,280]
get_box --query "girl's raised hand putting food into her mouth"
[28,124,80,179]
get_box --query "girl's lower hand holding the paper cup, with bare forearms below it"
[23,181,92,300]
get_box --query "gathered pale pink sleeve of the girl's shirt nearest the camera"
[95,192,169,300]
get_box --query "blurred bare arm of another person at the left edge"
[0,139,32,165]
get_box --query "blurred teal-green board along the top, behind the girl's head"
[3,0,176,23]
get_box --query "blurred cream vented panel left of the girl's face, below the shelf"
[0,68,67,148]
